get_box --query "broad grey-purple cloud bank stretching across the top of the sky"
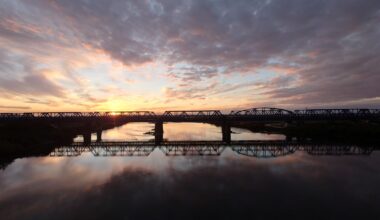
[0,0,380,108]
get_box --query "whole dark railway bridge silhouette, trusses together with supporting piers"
[0,107,380,145]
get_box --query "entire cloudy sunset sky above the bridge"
[0,0,380,112]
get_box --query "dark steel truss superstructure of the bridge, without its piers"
[0,107,380,122]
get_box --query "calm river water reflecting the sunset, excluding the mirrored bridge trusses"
[0,123,380,219]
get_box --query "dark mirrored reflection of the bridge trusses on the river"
[50,141,380,158]
